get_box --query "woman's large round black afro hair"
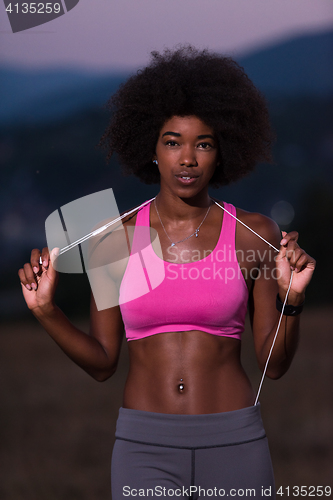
[99,45,274,187]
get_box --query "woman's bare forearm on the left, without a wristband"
[32,305,116,381]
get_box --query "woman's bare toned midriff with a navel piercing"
[123,331,254,414]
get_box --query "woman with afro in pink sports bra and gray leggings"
[19,47,315,500]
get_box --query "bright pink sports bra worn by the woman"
[119,203,248,340]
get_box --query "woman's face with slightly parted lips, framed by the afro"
[155,116,218,197]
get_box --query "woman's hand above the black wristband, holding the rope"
[276,231,316,300]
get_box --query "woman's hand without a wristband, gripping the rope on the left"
[18,247,59,310]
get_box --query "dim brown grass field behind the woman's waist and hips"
[0,308,333,500]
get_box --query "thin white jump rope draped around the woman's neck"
[48,196,294,406]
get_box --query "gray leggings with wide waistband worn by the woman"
[111,404,275,500]
